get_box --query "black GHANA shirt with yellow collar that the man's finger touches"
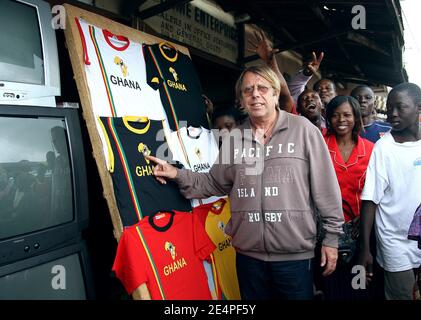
[99,117,191,226]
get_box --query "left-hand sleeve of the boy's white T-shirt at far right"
[361,145,389,204]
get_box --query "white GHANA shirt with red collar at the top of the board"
[75,18,168,165]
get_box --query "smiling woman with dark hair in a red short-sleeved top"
[324,96,374,299]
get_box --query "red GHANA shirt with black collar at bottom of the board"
[113,211,215,300]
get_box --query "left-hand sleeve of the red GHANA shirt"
[112,230,147,294]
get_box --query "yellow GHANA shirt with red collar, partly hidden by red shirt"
[193,198,241,300]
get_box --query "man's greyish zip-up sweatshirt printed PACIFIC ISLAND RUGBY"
[175,111,344,261]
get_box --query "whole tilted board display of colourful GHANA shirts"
[72,11,230,300]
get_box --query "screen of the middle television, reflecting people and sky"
[0,116,74,239]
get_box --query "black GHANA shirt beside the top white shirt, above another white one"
[143,42,209,131]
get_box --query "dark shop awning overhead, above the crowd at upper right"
[216,0,407,86]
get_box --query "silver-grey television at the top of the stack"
[0,0,61,107]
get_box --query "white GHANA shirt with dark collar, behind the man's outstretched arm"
[171,126,219,207]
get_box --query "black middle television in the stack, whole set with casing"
[0,106,89,266]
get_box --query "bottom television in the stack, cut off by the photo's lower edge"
[0,242,95,300]
